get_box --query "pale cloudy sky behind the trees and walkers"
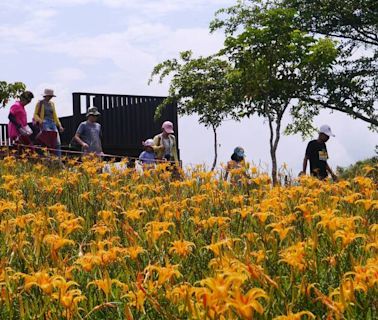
[0,0,378,173]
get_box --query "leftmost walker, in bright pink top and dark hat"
[8,91,34,144]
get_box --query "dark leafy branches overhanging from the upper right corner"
[279,0,378,130]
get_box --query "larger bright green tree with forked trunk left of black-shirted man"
[212,4,337,184]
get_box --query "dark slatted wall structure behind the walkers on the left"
[0,92,179,157]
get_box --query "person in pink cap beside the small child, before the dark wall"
[153,121,179,163]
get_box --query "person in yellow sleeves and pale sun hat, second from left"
[34,89,64,157]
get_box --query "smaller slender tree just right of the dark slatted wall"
[150,51,232,170]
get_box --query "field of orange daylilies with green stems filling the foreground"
[0,156,378,319]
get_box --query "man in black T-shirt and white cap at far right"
[300,124,337,181]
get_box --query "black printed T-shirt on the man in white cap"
[306,140,328,179]
